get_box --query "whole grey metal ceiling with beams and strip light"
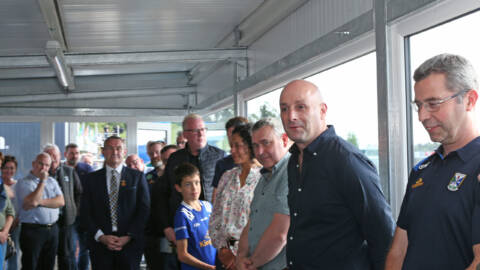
[0,0,306,116]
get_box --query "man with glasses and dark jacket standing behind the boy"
[158,114,225,260]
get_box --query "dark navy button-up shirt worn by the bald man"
[287,126,395,270]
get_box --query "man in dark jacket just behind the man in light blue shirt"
[43,144,82,270]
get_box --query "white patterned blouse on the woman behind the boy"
[209,167,262,254]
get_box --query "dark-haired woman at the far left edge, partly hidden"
[1,156,20,270]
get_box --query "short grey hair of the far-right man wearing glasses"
[413,53,478,92]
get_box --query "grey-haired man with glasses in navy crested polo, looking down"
[385,54,480,270]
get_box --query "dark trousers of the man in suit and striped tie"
[90,240,143,270]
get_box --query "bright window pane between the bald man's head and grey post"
[306,52,378,168]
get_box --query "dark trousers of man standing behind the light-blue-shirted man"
[58,225,77,270]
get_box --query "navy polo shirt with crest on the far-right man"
[397,137,480,270]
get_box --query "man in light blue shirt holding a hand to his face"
[15,153,65,270]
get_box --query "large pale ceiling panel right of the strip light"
[61,0,263,52]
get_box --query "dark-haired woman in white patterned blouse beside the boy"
[209,124,261,269]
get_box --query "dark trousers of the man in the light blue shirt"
[20,223,58,270]
